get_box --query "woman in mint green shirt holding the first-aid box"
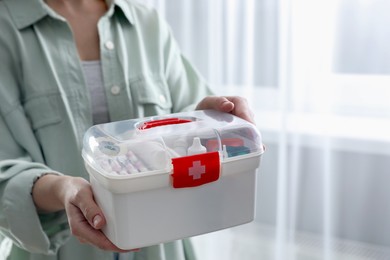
[0,0,253,260]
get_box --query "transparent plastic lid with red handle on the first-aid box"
[82,110,263,176]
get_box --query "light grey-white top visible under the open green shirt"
[82,60,110,124]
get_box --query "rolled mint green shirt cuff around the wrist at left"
[2,169,70,254]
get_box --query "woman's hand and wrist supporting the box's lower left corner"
[33,174,127,252]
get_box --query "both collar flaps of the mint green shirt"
[4,0,134,29]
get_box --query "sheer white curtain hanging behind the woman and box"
[144,0,390,260]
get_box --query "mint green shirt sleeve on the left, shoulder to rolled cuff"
[0,29,69,254]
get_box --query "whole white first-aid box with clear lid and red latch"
[82,110,263,249]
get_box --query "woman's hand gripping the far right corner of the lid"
[196,96,255,124]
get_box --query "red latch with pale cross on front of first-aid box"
[171,152,220,188]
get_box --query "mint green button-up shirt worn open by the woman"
[0,0,212,260]
